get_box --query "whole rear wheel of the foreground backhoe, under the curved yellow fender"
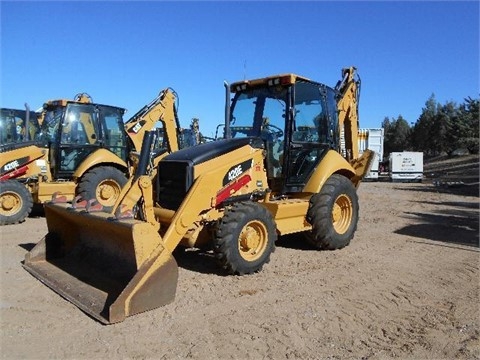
[305,174,359,250]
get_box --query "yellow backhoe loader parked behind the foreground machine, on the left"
[0,88,188,225]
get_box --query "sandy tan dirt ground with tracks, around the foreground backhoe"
[0,182,480,359]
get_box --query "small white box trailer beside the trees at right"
[389,151,423,182]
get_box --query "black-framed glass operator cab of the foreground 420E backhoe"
[230,74,339,193]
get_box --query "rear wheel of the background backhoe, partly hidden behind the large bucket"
[78,166,127,211]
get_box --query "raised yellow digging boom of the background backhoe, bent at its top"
[125,88,180,152]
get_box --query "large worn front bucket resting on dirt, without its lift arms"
[23,204,178,324]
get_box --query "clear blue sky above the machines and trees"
[0,0,480,135]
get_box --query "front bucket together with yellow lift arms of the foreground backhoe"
[23,134,263,324]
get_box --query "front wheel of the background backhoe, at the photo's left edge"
[0,180,33,225]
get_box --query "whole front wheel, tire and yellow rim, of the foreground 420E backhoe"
[213,202,277,275]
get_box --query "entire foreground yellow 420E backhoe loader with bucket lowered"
[23,67,373,324]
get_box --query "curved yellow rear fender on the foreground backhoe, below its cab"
[303,150,355,194]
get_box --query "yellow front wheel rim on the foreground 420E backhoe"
[238,221,268,261]
